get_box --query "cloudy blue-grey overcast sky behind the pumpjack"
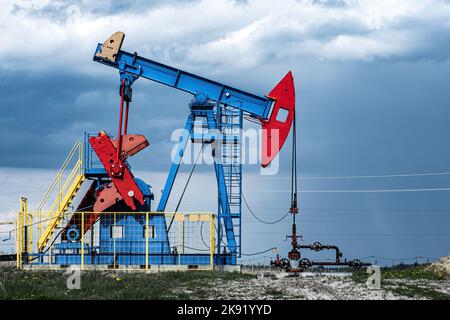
[0,0,450,264]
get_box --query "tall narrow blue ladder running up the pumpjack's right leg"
[219,104,243,258]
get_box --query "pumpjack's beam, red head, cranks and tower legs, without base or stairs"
[89,32,295,264]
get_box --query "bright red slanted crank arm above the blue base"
[89,131,148,211]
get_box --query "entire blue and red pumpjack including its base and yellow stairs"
[24,31,295,265]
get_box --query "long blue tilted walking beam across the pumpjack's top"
[94,44,274,120]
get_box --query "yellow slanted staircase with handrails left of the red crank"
[37,141,85,252]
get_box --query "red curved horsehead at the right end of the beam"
[261,71,295,167]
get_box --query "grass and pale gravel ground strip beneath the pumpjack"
[0,265,450,300]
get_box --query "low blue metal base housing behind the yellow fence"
[54,213,214,266]
